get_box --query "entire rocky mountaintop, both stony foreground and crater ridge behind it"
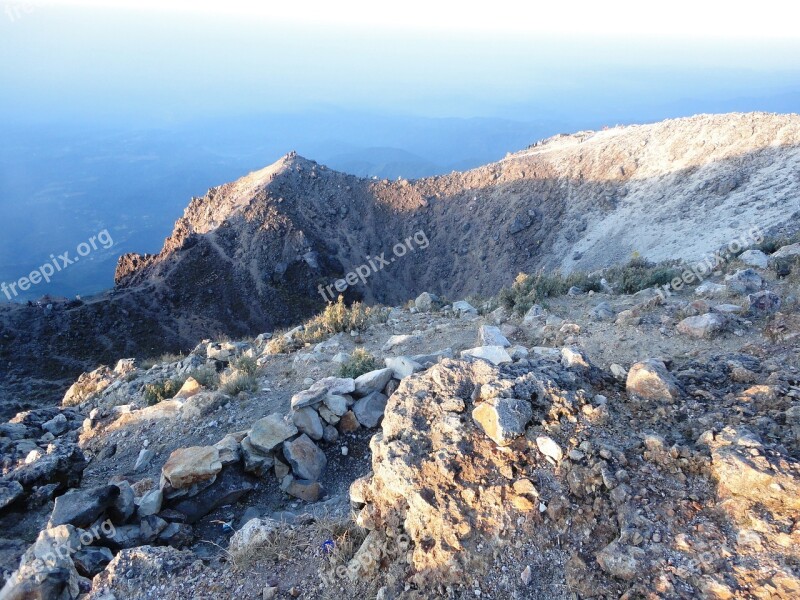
[0,114,800,600]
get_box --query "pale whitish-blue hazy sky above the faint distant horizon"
[0,0,800,121]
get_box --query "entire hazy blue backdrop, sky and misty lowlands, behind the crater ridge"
[0,0,800,301]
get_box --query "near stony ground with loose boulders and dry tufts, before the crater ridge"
[0,237,800,600]
